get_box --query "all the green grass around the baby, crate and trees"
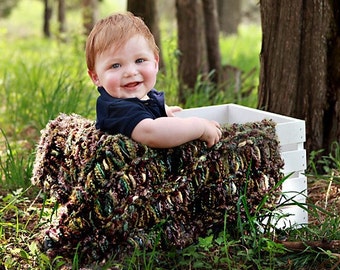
[0,1,340,269]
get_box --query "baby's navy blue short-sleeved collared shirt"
[96,87,167,138]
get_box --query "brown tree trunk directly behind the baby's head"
[127,0,164,70]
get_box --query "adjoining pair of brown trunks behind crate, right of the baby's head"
[176,0,220,104]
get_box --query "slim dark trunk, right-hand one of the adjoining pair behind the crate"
[203,0,221,85]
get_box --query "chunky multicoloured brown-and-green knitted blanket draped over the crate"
[32,114,283,261]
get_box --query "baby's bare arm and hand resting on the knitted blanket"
[131,117,222,148]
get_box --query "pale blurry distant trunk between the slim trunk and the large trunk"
[217,0,242,35]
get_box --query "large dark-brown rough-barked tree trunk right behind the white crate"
[258,0,340,158]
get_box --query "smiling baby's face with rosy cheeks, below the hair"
[89,35,159,99]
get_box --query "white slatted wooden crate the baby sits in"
[176,104,308,228]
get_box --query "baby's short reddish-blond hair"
[86,12,158,71]
